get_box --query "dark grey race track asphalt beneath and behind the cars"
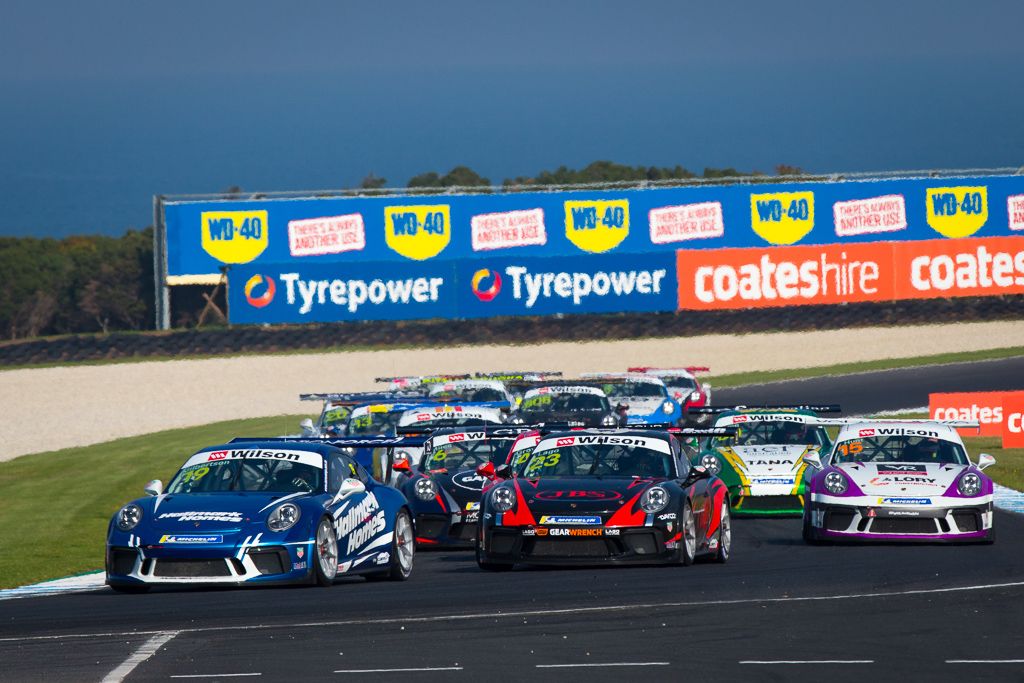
[0,359,1024,683]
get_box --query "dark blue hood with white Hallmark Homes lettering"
[139,493,308,532]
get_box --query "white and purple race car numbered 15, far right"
[804,421,995,543]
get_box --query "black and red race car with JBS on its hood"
[476,425,732,569]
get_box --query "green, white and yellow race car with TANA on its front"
[692,405,839,516]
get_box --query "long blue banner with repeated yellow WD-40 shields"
[163,175,1024,278]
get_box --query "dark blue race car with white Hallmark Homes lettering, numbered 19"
[106,438,422,592]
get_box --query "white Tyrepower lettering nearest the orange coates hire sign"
[505,265,669,308]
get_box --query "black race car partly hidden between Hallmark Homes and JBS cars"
[400,426,526,548]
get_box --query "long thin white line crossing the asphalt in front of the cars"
[6,581,1024,643]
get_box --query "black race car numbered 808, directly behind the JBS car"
[511,383,618,427]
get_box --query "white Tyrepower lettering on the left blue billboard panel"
[279,272,444,315]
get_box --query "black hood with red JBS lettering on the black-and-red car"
[517,477,664,523]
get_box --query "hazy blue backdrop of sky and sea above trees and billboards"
[0,0,1024,238]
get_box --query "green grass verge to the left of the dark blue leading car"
[0,416,307,588]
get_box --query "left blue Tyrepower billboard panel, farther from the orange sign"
[227,262,457,323]
